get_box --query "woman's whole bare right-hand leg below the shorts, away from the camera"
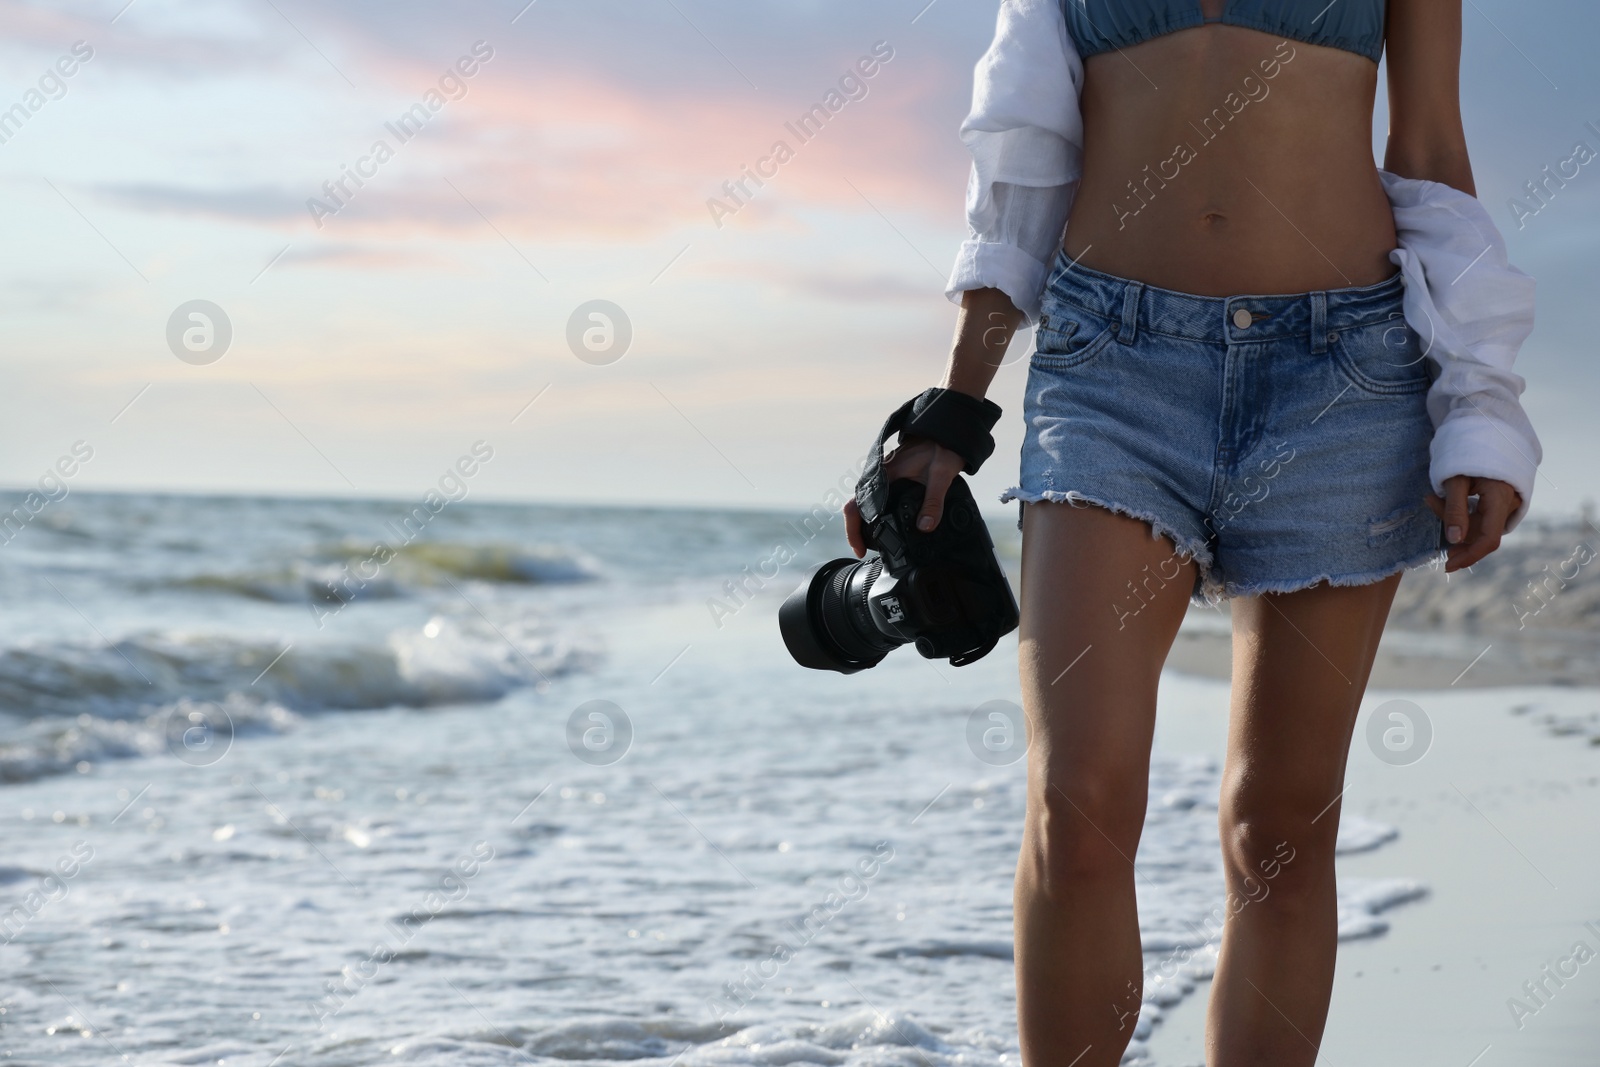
[1206,574,1400,1067]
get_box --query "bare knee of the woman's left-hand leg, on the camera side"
[1026,773,1146,897]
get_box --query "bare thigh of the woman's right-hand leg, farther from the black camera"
[1224,574,1400,809]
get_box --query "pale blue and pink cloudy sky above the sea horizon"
[0,0,1600,514]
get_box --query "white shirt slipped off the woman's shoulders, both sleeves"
[946,0,1544,530]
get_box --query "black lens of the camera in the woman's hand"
[778,558,904,673]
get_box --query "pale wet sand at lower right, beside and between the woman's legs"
[1150,686,1600,1067]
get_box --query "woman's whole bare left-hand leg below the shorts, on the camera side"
[1014,504,1195,1067]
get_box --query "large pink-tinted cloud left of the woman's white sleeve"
[81,67,963,242]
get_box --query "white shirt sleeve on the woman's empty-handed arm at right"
[1378,171,1544,530]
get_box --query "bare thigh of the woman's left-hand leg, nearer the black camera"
[1019,502,1195,799]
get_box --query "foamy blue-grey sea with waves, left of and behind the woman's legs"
[0,491,1427,1067]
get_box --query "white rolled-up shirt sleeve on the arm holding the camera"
[946,0,1083,323]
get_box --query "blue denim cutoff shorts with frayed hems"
[1000,253,1442,603]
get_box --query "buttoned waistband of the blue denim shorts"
[1045,250,1405,352]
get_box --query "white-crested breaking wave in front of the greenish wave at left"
[0,614,594,718]
